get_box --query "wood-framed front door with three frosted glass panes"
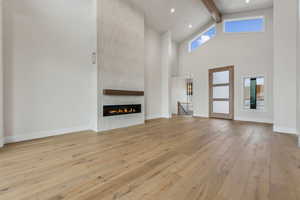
[209,66,234,119]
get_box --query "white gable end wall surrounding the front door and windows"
[179,9,273,123]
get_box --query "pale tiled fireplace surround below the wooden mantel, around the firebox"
[99,95,145,131]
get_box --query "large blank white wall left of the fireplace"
[4,0,97,142]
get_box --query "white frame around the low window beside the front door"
[241,74,268,113]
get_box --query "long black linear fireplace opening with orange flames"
[103,104,142,117]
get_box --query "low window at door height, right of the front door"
[243,76,265,111]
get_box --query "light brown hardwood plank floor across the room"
[0,118,300,200]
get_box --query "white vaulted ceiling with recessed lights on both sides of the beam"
[127,0,273,42]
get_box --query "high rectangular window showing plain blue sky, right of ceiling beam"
[224,17,265,33]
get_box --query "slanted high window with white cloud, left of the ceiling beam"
[189,25,217,52]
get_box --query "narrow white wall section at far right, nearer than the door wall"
[274,0,298,133]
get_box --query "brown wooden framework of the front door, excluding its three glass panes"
[208,65,234,120]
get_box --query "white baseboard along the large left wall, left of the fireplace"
[4,126,91,144]
